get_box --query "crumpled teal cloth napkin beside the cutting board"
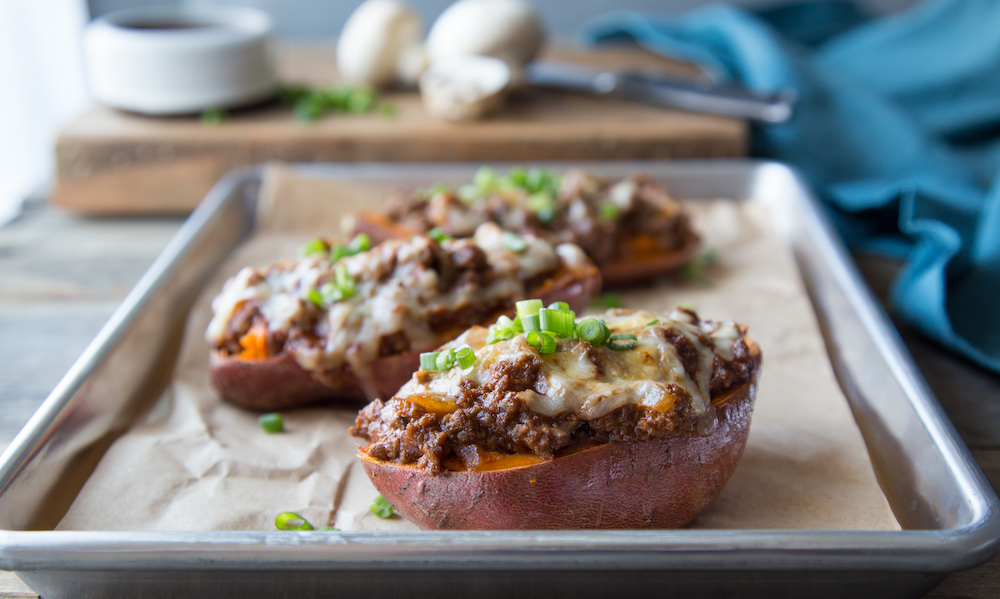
[582,0,1000,372]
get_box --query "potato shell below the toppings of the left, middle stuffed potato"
[209,253,601,411]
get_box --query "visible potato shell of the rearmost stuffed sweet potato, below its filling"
[351,212,701,287]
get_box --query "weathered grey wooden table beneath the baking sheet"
[0,203,1000,599]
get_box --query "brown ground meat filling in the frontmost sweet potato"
[351,314,759,473]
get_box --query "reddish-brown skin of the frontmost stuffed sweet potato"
[360,378,757,530]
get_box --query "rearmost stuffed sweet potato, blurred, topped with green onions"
[346,167,700,285]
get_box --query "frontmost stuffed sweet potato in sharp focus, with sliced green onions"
[352,303,761,530]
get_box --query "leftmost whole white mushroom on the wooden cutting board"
[337,0,427,87]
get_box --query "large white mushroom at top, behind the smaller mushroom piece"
[426,0,545,69]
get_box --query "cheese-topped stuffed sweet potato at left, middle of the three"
[206,223,601,410]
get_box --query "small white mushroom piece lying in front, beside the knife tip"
[420,55,511,121]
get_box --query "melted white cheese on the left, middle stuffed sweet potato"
[205,223,564,394]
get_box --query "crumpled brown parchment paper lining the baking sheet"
[58,167,899,530]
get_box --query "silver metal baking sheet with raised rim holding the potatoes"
[0,161,1000,599]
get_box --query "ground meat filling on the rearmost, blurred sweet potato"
[378,170,697,266]
